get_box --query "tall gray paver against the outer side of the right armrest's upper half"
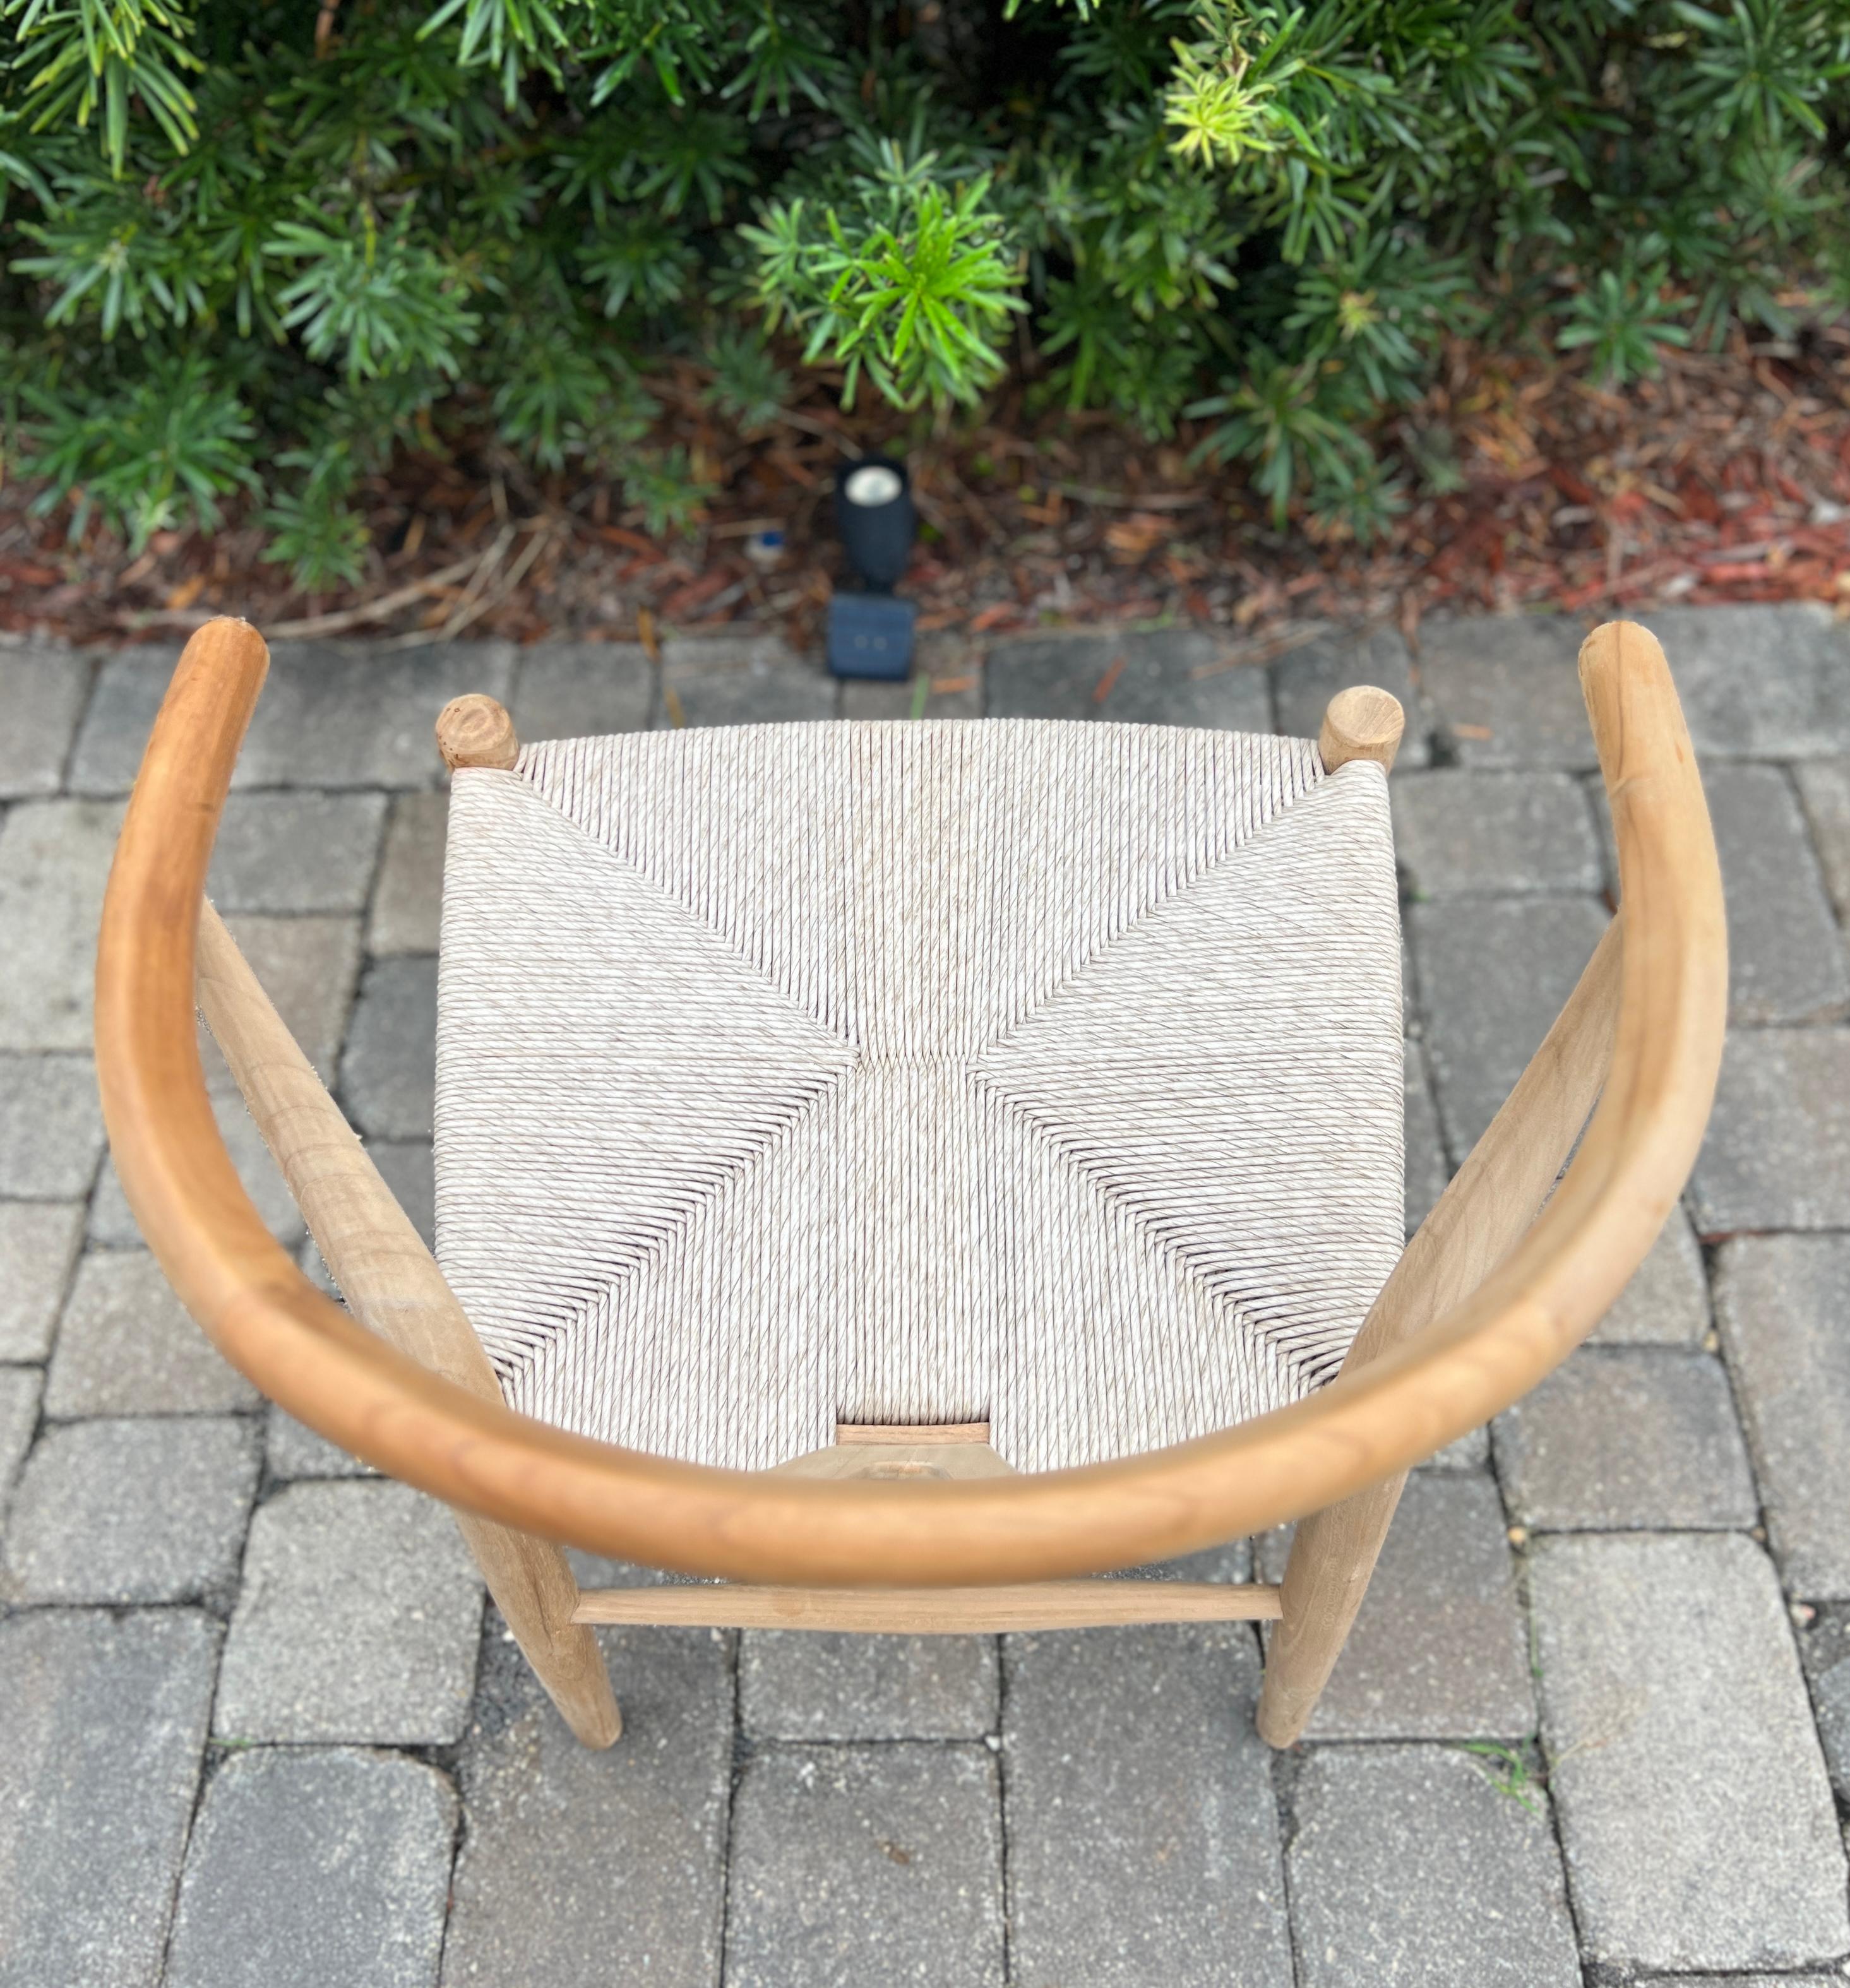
[1703,765,1850,1022]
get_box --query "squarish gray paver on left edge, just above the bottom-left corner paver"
[6,1415,256,1602]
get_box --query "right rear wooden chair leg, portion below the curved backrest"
[1259,1471,1406,1747]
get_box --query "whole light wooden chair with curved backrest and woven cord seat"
[95,620,1727,1746]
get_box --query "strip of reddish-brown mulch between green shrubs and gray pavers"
[0,320,1850,656]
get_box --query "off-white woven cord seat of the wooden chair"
[436,720,1402,1471]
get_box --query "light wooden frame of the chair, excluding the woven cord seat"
[95,620,1727,1746]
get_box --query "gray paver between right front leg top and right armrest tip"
[1420,614,1599,768]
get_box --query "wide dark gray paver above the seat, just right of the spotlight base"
[989,628,1271,732]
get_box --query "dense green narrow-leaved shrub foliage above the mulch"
[0,0,1850,586]
